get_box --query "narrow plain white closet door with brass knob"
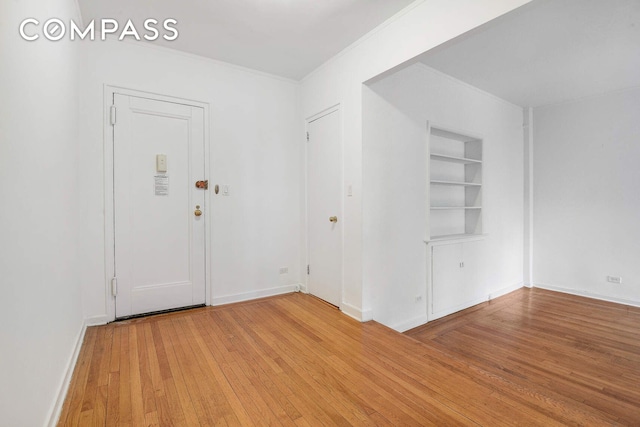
[307,110,343,307]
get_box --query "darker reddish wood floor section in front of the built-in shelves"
[407,289,640,426]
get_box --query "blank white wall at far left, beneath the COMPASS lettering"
[0,0,82,426]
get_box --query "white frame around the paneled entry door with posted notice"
[102,84,212,322]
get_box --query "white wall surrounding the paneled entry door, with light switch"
[79,41,303,322]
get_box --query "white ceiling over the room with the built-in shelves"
[420,0,640,107]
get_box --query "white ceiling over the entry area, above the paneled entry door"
[79,0,414,80]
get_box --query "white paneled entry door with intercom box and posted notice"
[113,94,206,318]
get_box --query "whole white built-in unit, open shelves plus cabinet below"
[425,123,485,320]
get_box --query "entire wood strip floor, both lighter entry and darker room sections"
[60,289,640,426]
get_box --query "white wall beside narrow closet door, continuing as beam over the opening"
[300,0,529,320]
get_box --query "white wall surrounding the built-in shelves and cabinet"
[362,64,523,330]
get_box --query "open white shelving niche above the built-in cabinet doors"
[427,123,482,242]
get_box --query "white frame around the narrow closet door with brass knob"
[301,103,345,311]
